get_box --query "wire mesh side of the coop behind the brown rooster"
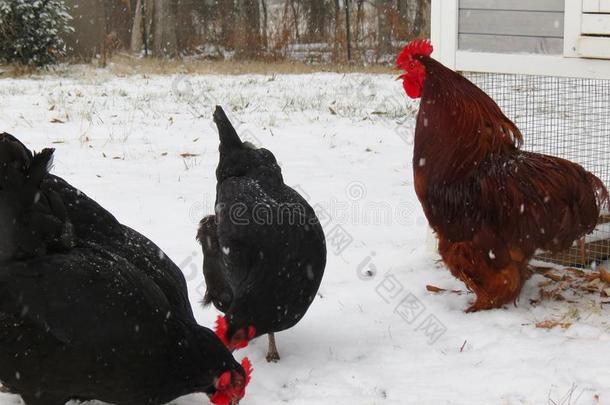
[465,73,610,267]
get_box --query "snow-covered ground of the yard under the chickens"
[0,69,610,405]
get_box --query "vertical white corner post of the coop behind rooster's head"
[431,0,459,69]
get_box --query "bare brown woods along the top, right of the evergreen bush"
[65,0,430,63]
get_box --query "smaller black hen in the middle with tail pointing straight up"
[198,107,326,361]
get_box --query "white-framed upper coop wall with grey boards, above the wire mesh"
[432,0,610,79]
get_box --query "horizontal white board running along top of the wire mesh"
[453,51,610,79]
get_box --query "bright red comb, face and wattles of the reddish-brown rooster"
[396,39,433,98]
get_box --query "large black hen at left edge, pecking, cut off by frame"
[0,134,250,405]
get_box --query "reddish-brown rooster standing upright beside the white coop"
[397,40,608,312]
